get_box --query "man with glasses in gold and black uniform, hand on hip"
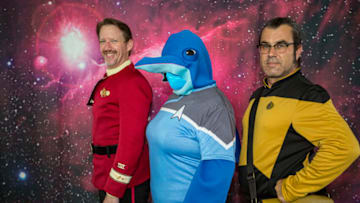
[239,18,360,202]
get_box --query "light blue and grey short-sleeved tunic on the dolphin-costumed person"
[146,84,235,203]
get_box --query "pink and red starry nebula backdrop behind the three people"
[0,0,360,203]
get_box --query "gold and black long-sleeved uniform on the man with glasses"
[239,69,360,201]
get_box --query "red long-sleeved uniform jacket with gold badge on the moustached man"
[88,61,152,198]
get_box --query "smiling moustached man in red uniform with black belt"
[88,18,152,203]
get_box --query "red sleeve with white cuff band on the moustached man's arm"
[104,72,152,198]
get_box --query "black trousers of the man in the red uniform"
[99,180,150,203]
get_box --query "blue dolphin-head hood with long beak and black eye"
[135,30,215,95]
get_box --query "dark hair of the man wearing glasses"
[259,17,302,66]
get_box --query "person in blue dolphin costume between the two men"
[136,30,235,203]
